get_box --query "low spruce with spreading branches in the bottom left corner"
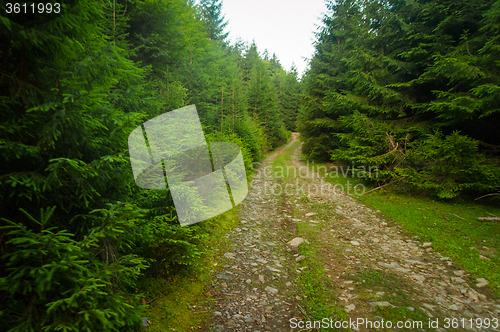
[0,207,147,331]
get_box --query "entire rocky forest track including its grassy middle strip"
[188,134,500,332]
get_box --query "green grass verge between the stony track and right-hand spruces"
[309,163,500,298]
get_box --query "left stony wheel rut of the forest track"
[206,136,296,331]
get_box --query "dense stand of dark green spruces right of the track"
[299,0,500,198]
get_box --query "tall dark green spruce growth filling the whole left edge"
[0,1,151,331]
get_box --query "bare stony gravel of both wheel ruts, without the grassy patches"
[207,134,500,332]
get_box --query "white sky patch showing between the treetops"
[222,0,326,77]
